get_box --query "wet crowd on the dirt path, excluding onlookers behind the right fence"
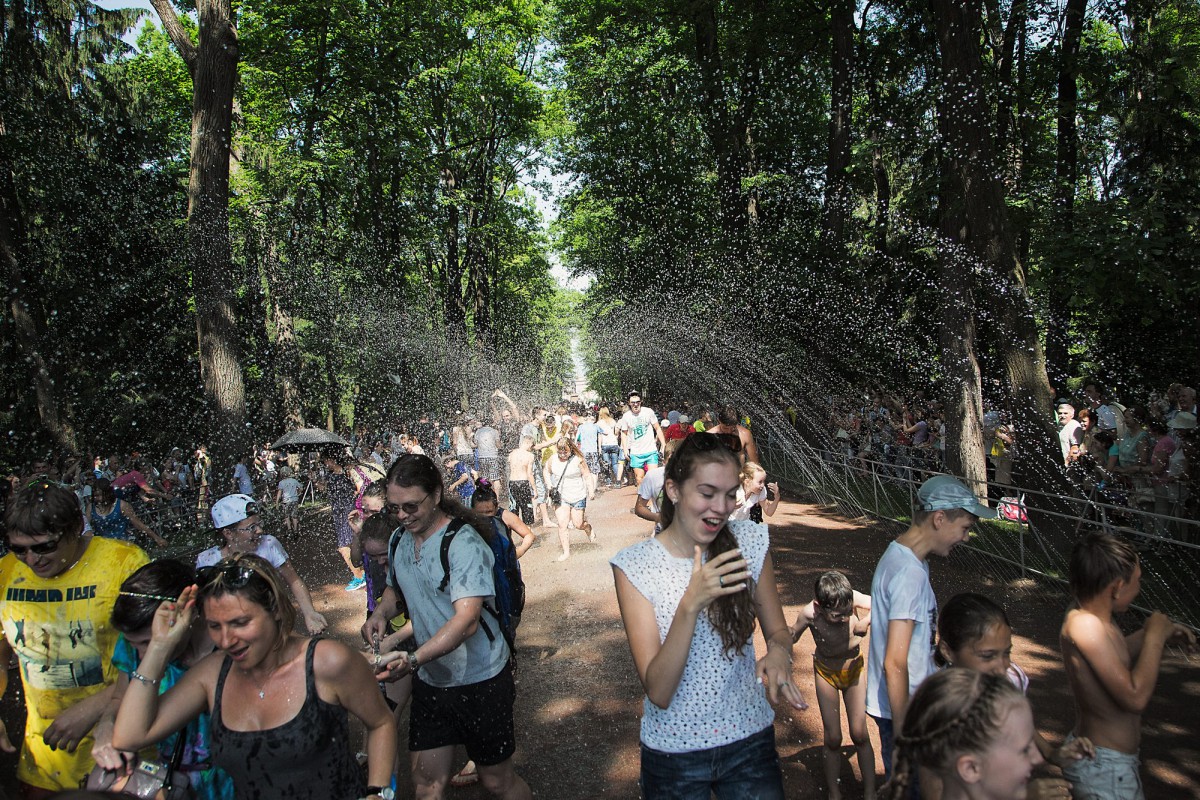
[0,390,1195,800]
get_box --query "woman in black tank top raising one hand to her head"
[113,554,396,800]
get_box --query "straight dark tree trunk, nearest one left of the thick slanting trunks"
[822,0,856,252]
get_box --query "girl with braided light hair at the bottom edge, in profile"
[883,667,1042,800]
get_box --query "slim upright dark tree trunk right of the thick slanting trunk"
[1046,0,1087,386]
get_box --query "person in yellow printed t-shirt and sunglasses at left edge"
[0,480,146,798]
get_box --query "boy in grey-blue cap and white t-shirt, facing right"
[866,475,996,781]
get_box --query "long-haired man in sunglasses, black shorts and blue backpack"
[362,455,532,800]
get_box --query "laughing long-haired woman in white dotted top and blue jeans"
[612,433,808,800]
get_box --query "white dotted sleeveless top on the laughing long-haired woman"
[610,521,775,753]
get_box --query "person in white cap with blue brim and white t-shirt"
[196,494,329,634]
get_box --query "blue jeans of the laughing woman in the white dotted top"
[641,726,784,800]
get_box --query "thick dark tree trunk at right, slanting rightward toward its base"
[930,0,1063,488]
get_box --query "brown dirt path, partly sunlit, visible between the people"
[0,488,1200,800]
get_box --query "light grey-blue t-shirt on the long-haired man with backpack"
[388,525,509,688]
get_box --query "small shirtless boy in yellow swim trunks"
[792,572,875,800]
